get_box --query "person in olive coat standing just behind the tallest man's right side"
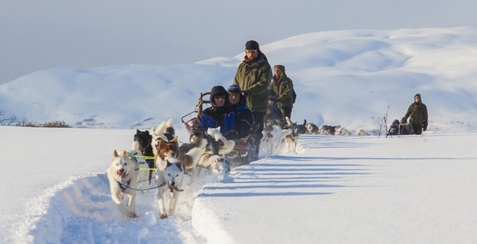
[269,65,294,119]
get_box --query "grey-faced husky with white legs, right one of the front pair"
[157,157,184,219]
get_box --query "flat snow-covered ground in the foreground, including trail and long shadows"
[0,127,477,243]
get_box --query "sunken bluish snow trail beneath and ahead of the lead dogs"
[13,173,204,243]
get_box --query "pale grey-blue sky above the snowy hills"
[0,0,477,83]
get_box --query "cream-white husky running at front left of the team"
[108,150,137,218]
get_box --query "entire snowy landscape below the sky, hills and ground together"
[0,28,477,243]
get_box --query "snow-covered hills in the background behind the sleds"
[0,27,477,133]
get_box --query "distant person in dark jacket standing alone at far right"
[401,93,428,135]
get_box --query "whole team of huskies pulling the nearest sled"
[107,119,235,219]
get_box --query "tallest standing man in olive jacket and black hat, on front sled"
[233,40,272,160]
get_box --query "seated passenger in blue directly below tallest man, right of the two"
[224,85,255,143]
